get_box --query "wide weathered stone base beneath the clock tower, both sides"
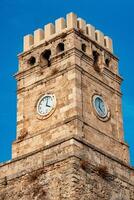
[0,138,134,200]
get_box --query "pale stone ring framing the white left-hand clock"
[35,93,57,119]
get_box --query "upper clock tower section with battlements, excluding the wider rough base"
[13,13,129,163]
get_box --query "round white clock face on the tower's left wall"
[37,94,56,116]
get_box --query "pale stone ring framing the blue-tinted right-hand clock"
[92,94,110,121]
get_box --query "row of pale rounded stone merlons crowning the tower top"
[23,13,113,53]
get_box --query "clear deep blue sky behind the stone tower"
[0,0,134,165]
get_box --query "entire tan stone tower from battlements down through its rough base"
[0,13,134,200]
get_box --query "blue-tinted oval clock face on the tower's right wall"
[93,95,108,118]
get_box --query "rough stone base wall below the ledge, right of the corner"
[70,158,134,200]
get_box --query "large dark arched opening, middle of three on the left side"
[40,49,51,67]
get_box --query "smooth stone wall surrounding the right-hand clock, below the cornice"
[73,68,129,163]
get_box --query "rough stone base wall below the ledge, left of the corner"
[0,159,73,200]
